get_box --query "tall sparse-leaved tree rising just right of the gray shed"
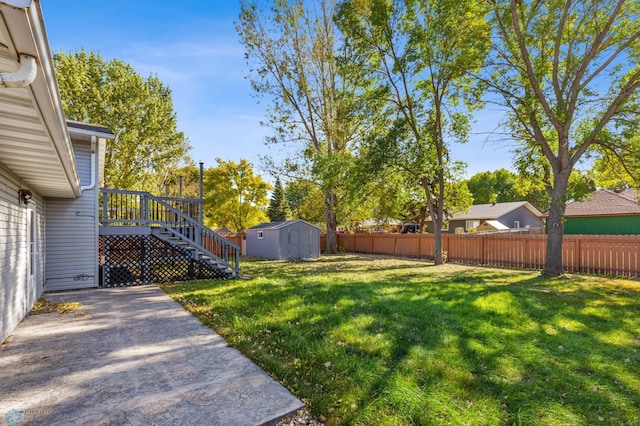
[237,0,364,253]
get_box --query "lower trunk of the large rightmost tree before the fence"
[542,169,571,276]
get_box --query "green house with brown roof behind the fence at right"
[564,189,640,235]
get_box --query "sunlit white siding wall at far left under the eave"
[0,164,45,342]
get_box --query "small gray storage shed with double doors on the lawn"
[247,220,320,259]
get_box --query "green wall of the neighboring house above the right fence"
[564,216,640,235]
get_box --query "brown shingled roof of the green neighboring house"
[565,189,640,217]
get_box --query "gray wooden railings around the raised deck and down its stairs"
[100,189,240,276]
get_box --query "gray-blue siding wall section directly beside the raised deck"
[45,140,98,291]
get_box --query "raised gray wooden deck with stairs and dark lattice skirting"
[100,189,240,287]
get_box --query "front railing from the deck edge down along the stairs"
[101,188,240,276]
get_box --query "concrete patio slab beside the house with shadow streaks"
[0,286,303,425]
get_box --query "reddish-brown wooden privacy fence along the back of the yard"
[321,233,640,277]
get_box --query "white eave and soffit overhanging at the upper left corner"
[0,0,80,198]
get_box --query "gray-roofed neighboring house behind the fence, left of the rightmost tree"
[427,201,544,233]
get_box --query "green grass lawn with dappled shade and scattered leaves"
[162,255,640,425]
